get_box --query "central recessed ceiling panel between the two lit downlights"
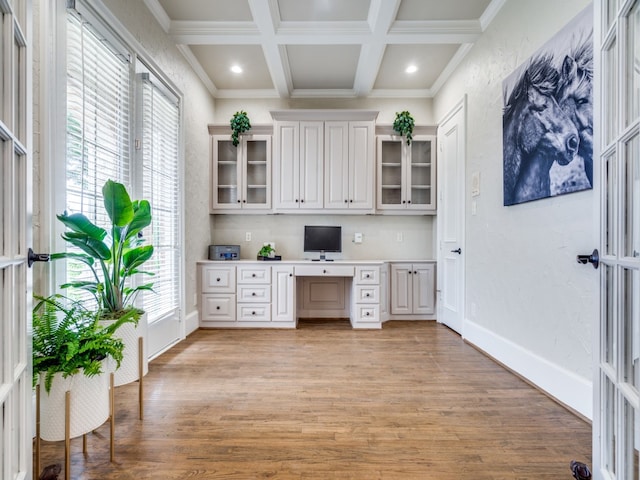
[286,45,360,89]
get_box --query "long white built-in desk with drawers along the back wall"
[198,260,435,329]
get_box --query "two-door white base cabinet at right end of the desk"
[390,262,436,320]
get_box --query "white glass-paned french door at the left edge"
[0,0,33,479]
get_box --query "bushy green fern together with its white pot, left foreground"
[32,295,134,441]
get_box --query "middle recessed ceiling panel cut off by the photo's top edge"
[278,0,371,22]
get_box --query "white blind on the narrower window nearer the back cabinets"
[140,73,180,323]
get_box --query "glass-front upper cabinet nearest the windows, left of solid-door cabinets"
[211,135,271,213]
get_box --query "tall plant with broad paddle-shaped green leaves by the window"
[51,180,153,319]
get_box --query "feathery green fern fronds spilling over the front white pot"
[32,294,135,393]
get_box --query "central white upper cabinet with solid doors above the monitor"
[271,110,377,213]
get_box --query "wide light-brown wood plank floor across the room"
[41,320,591,480]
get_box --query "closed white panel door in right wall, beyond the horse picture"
[437,100,466,334]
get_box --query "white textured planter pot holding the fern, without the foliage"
[40,365,110,442]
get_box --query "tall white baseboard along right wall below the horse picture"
[462,320,593,421]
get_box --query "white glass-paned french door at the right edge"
[593,0,640,480]
